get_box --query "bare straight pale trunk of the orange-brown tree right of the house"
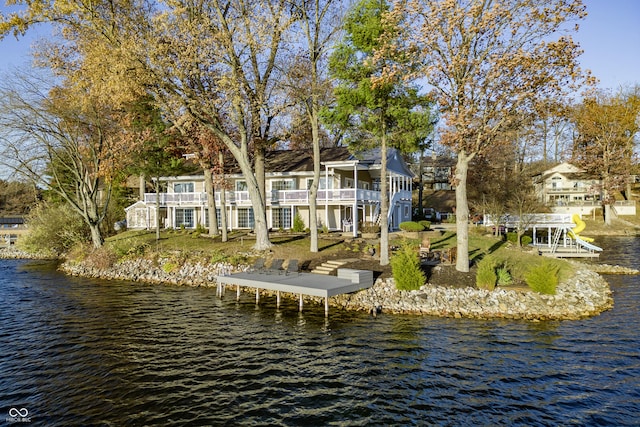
[455,151,473,273]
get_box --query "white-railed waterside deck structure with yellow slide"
[487,214,602,258]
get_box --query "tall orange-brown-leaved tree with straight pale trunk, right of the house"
[404,0,586,271]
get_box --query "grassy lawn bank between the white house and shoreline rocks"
[90,228,574,286]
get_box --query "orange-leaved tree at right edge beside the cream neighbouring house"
[573,86,640,225]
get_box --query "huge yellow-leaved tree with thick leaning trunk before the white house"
[0,0,297,250]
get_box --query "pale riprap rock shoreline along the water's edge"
[0,247,639,321]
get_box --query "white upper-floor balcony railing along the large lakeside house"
[144,188,411,207]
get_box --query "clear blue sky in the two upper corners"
[0,0,640,89]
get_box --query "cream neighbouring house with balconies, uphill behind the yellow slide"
[533,162,635,215]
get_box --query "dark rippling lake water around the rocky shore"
[0,238,640,426]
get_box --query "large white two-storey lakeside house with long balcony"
[125,147,413,234]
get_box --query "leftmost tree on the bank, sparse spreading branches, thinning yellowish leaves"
[0,73,126,248]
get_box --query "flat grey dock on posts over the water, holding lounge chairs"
[216,268,373,316]
